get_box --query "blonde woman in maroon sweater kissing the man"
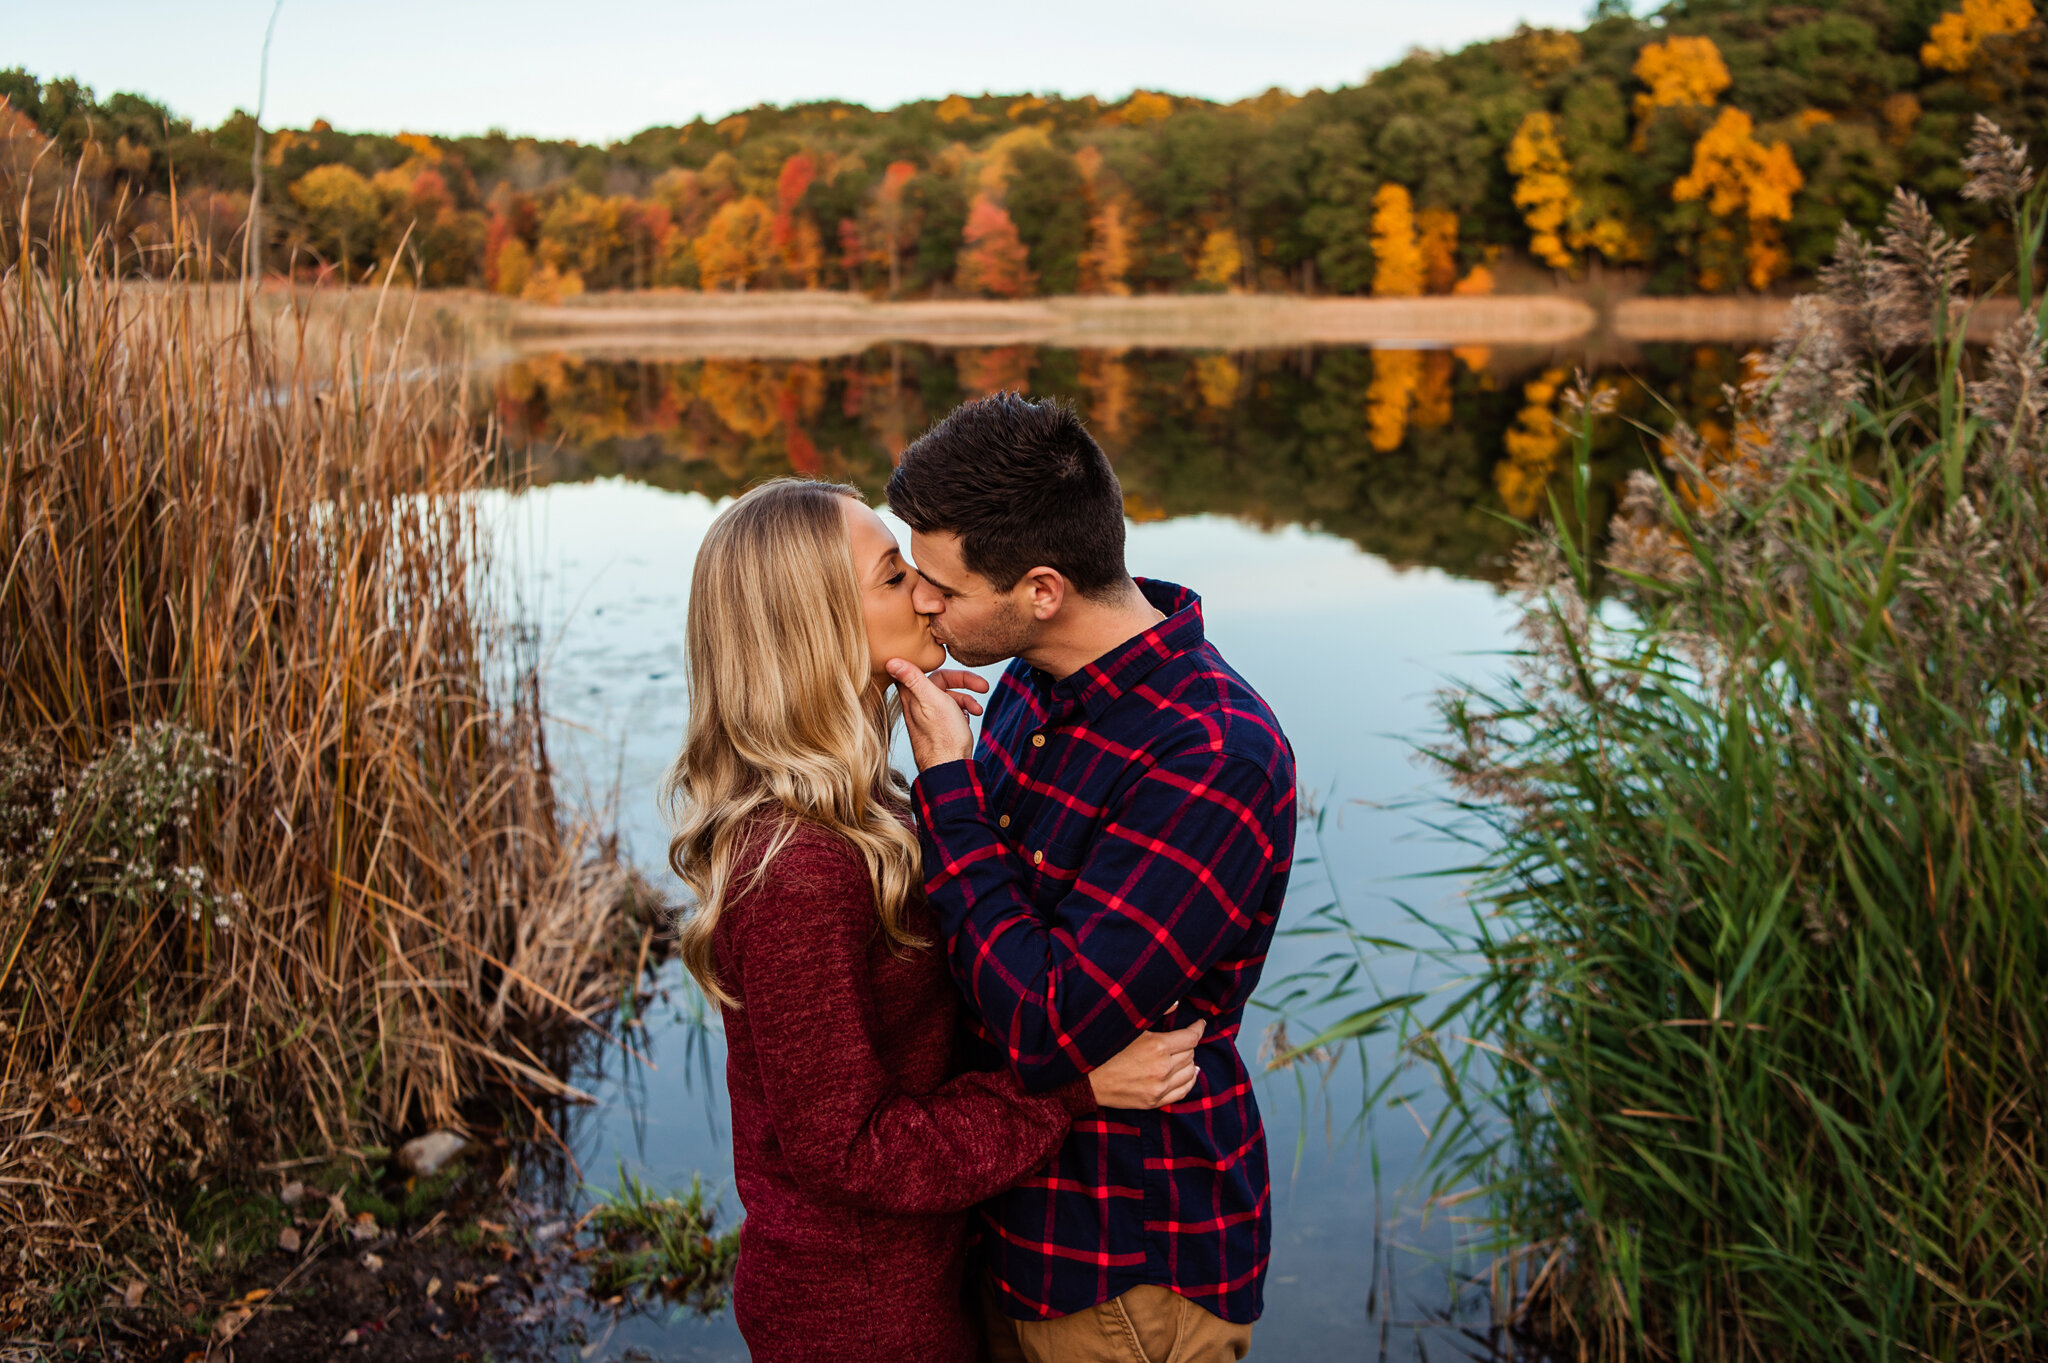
[668,479,1200,1363]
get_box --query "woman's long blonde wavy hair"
[664,479,924,1007]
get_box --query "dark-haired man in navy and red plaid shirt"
[889,393,1294,1363]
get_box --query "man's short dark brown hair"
[889,393,1130,598]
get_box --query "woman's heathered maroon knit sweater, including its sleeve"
[713,819,1096,1363]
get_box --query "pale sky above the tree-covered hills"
[0,0,1589,141]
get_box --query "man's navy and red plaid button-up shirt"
[913,581,1294,1322]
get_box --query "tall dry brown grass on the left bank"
[0,196,625,1320]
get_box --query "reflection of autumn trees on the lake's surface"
[489,346,1739,577]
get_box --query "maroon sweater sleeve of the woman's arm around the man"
[731,822,1096,1214]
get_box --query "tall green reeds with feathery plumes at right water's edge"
[1419,127,2048,1361]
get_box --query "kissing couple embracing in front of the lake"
[668,393,1294,1363]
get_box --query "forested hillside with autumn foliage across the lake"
[0,0,2048,299]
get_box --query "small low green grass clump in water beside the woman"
[588,1164,739,1316]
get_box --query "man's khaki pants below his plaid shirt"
[981,1275,1251,1363]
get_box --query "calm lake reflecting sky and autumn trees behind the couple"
[485,333,1741,1359]
